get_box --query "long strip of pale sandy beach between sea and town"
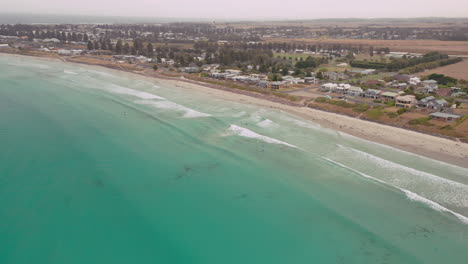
[0,53,468,168]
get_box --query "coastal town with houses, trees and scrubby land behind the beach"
[0,20,468,141]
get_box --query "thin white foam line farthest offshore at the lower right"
[321,157,468,225]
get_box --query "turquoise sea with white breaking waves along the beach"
[0,56,468,264]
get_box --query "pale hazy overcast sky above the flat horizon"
[0,0,468,19]
